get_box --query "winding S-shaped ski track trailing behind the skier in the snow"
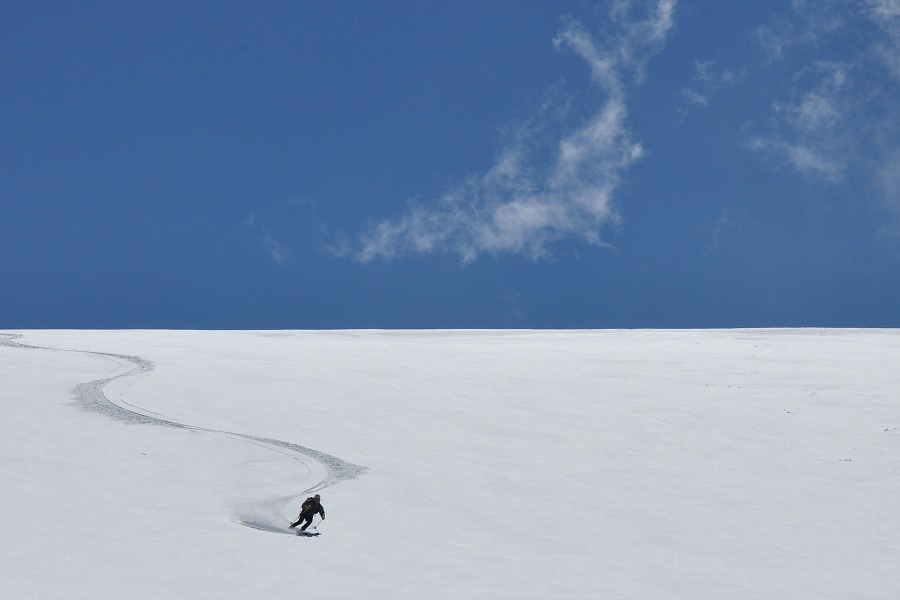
[0,333,368,535]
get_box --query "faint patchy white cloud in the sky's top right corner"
[748,0,900,217]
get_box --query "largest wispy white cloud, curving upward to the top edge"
[339,0,676,263]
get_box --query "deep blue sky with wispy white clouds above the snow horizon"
[0,0,900,329]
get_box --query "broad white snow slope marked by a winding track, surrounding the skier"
[0,330,900,600]
